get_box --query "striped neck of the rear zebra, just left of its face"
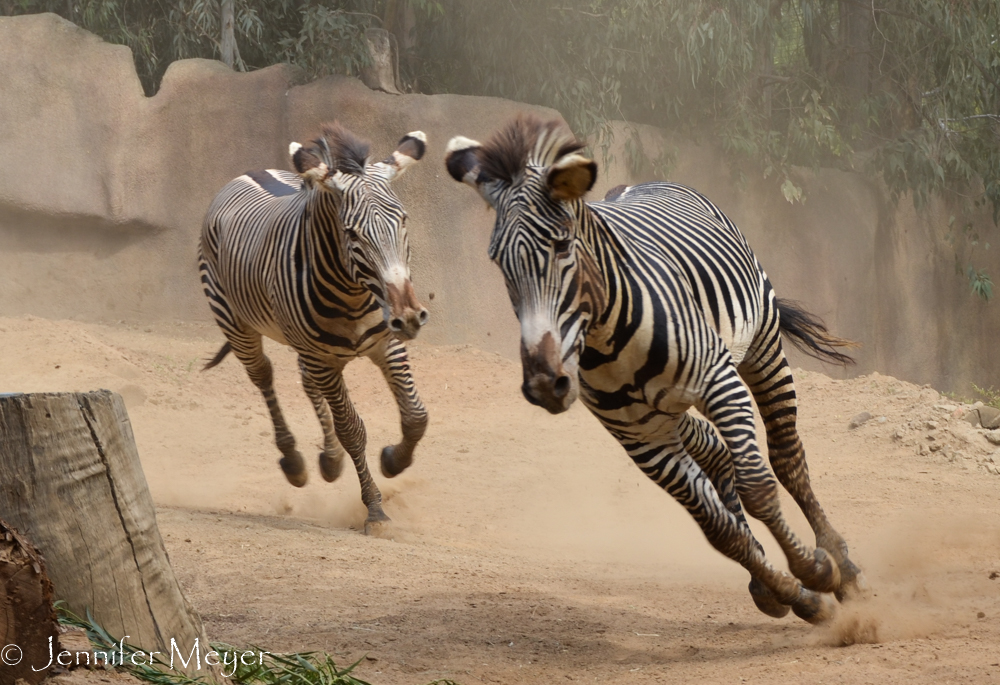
[300,190,371,306]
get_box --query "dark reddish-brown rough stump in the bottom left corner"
[0,521,59,685]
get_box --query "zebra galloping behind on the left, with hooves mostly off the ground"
[199,122,428,533]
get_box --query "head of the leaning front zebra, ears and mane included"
[446,116,604,414]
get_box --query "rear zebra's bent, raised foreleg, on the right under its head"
[370,338,427,478]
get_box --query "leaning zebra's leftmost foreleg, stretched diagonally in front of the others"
[625,428,834,623]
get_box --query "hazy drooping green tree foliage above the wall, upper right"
[410,0,1000,299]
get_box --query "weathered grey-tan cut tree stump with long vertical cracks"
[0,390,218,676]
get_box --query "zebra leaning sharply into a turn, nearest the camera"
[445,115,867,623]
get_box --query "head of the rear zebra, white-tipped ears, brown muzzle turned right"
[289,122,430,340]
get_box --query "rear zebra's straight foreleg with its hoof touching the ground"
[299,356,389,535]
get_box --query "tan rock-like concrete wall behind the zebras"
[0,15,1000,389]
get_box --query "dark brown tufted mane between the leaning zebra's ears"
[476,114,585,183]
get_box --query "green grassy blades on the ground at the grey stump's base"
[56,603,458,685]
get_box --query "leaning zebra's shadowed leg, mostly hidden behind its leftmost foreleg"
[679,412,788,618]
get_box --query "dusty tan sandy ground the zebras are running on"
[0,317,1000,685]
